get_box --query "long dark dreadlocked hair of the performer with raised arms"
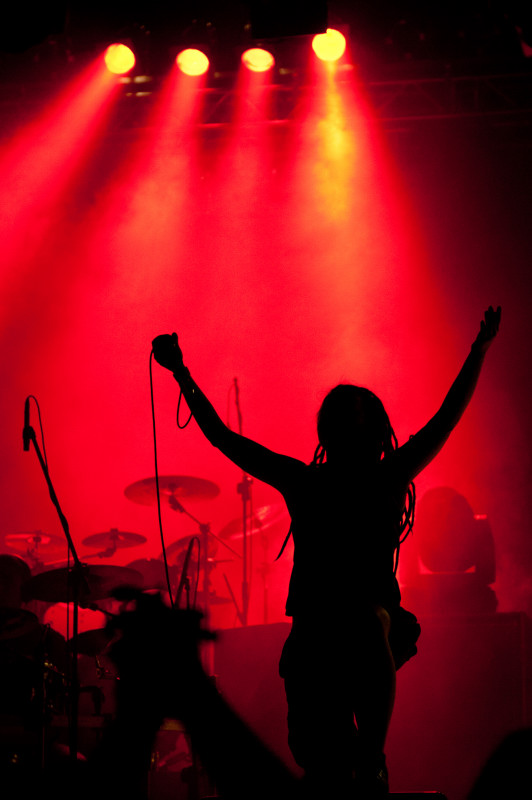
[311,383,416,574]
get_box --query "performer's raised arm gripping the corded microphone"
[152,333,304,492]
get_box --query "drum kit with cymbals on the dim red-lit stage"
[0,475,286,780]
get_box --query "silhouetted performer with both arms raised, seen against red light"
[153,306,500,798]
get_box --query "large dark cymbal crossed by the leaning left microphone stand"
[26,564,142,606]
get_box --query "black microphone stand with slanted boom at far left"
[23,424,87,767]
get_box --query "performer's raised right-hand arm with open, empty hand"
[395,306,501,480]
